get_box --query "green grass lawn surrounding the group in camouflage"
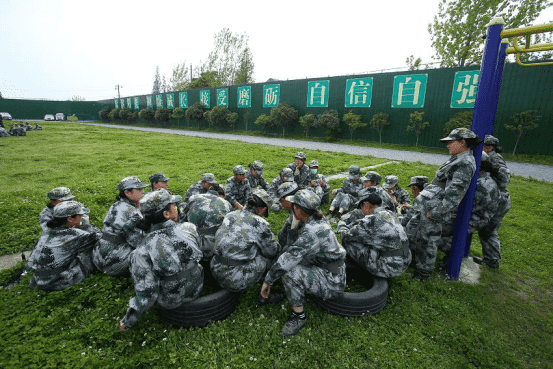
[0,123,553,368]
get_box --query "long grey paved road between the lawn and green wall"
[86,123,553,182]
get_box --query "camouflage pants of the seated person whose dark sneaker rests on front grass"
[282,265,346,307]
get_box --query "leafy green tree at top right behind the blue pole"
[428,0,552,67]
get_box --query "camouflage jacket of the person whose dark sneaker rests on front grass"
[265,216,346,285]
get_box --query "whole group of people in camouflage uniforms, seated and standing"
[26,129,510,335]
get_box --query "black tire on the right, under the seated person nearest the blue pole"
[312,268,388,318]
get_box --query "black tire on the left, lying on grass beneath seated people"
[156,289,240,328]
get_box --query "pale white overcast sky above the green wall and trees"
[0,0,553,101]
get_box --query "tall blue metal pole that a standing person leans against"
[447,18,505,279]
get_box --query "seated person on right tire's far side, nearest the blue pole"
[337,191,411,278]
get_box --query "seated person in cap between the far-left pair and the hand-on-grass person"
[93,176,147,276]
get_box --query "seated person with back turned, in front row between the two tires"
[211,188,283,302]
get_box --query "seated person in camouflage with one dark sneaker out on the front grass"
[261,190,346,336]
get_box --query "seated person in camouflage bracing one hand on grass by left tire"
[119,189,204,331]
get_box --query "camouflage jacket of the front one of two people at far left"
[27,226,100,291]
